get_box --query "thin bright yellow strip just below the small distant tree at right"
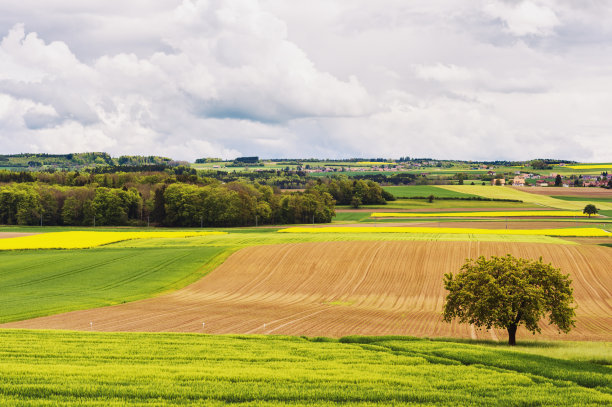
[370,211,588,218]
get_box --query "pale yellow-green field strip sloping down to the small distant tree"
[440,185,612,210]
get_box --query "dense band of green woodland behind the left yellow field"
[0,181,335,226]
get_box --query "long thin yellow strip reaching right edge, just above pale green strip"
[279,226,612,237]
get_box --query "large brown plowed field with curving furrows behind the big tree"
[0,241,612,341]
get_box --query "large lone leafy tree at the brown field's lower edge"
[443,254,576,345]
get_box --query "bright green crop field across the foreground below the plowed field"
[0,330,612,406]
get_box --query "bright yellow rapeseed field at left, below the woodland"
[0,232,225,250]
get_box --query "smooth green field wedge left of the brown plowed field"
[0,246,229,322]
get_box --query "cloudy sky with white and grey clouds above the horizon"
[0,0,612,162]
